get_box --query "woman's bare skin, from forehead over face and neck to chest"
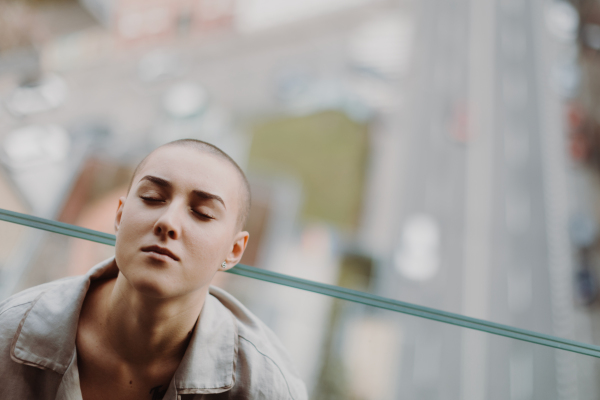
[76,147,248,400]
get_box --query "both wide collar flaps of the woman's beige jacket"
[11,257,238,394]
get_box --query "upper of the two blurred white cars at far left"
[5,74,67,117]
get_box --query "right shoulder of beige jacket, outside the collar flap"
[210,287,307,400]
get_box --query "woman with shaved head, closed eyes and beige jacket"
[0,139,307,400]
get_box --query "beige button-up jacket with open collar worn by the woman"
[0,258,307,400]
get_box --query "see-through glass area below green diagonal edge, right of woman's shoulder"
[218,274,599,400]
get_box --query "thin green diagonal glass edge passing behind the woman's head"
[0,209,600,358]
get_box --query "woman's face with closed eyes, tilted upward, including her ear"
[115,146,248,298]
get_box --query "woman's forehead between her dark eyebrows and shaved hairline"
[133,146,240,203]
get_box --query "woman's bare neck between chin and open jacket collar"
[100,273,208,365]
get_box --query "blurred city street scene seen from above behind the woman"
[0,0,600,400]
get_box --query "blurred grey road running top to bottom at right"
[366,0,584,400]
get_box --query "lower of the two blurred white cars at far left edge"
[0,124,71,170]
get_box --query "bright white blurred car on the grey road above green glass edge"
[394,214,440,281]
